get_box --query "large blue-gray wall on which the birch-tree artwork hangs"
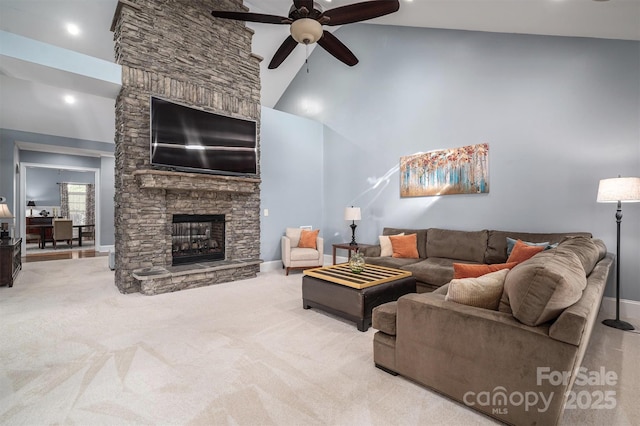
[276,24,640,300]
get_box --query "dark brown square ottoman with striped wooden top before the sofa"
[302,265,416,331]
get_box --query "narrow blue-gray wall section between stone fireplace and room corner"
[260,107,323,261]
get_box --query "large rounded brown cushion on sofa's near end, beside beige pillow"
[500,247,587,326]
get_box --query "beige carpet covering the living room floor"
[0,257,640,425]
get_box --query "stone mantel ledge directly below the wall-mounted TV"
[133,170,261,194]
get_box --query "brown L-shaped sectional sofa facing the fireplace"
[366,228,615,425]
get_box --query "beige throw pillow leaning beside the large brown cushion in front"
[444,269,509,311]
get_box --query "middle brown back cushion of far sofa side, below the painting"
[427,228,488,263]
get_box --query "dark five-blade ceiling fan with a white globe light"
[211,0,400,69]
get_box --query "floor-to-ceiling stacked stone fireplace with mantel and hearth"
[112,0,261,295]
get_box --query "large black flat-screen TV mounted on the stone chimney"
[151,96,257,175]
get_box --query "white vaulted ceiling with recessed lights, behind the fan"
[0,0,640,142]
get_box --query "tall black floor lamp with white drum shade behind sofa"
[597,176,640,330]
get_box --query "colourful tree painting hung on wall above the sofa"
[400,143,489,198]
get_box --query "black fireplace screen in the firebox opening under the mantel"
[171,214,225,265]
